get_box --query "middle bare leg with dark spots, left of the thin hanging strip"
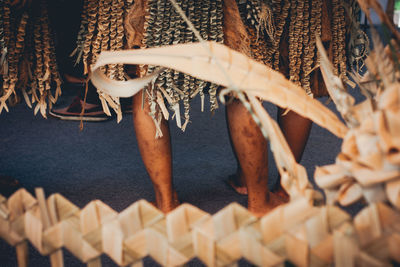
[227,100,281,216]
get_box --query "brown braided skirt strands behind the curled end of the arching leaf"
[73,0,133,121]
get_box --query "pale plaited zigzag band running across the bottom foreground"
[0,189,400,266]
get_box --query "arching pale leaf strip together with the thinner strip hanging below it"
[91,42,347,198]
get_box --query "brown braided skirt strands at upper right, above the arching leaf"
[237,0,356,95]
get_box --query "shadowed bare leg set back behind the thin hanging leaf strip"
[275,108,312,197]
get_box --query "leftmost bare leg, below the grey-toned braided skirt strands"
[132,92,179,213]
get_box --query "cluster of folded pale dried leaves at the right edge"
[315,1,400,209]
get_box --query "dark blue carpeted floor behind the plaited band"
[0,81,366,267]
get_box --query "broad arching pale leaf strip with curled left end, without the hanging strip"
[92,42,347,136]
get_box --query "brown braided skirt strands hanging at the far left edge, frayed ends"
[0,0,61,117]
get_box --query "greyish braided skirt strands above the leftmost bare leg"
[140,0,224,130]
